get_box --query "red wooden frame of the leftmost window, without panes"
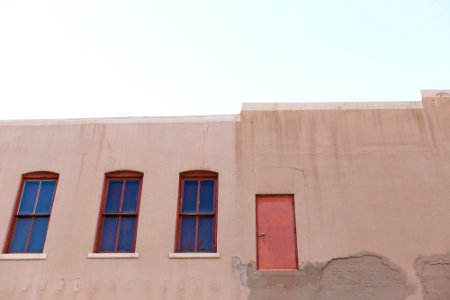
[3,171,59,253]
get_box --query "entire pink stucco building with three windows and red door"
[0,91,450,300]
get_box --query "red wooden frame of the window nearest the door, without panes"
[175,171,219,253]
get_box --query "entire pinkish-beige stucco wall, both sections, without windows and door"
[0,92,450,300]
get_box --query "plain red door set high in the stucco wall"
[256,195,297,270]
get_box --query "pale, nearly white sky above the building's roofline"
[0,0,450,120]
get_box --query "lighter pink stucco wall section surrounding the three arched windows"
[0,117,246,299]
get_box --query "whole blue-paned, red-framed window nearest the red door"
[175,171,217,252]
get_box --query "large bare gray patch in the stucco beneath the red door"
[233,254,413,300]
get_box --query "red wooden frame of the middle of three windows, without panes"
[94,171,144,253]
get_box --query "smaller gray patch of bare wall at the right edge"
[414,254,450,300]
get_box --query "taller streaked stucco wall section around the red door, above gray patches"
[236,92,450,300]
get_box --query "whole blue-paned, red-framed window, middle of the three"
[95,171,143,252]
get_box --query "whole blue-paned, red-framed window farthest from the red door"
[5,172,58,253]
